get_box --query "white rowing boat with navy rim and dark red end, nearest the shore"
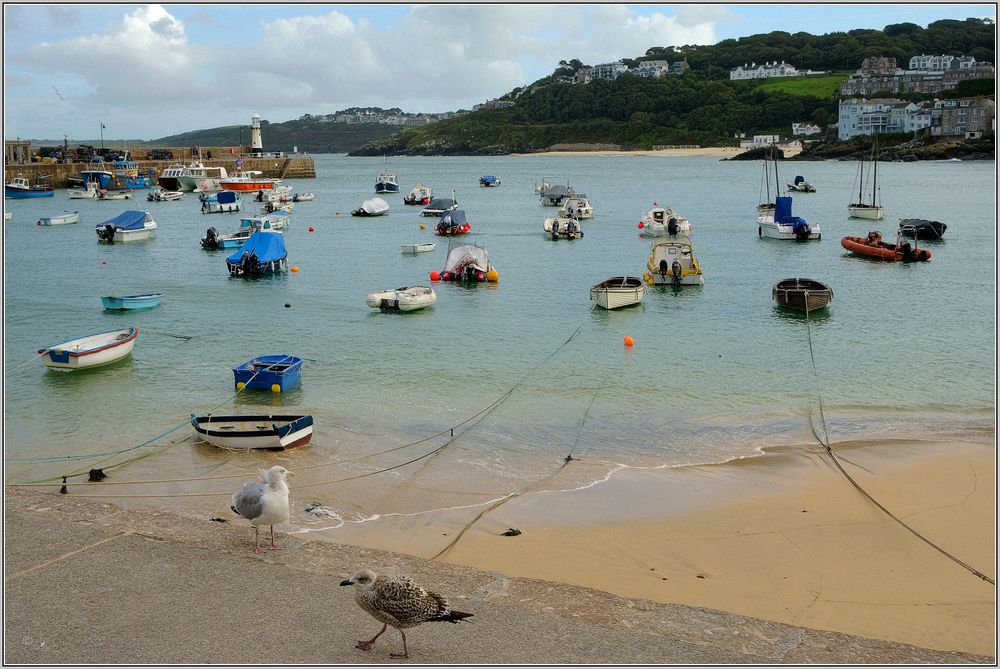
[191,414,313,451]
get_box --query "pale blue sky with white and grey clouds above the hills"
[3,3,996,141]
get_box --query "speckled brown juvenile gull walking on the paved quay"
[340,569,472,659]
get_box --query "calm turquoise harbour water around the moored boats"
[4,155,996,528]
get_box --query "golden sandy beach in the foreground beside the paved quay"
[328,442,996,655]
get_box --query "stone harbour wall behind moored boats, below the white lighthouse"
[4,156,316,188]
